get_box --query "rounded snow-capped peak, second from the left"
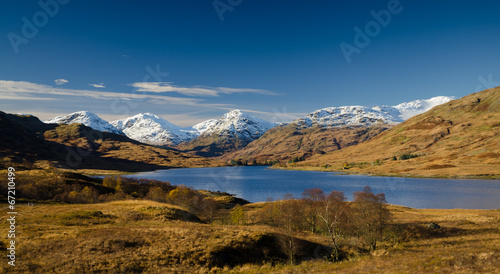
[111,113,200,145]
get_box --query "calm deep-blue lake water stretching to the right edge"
[123,167,500,209]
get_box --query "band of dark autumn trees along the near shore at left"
[0,169,243,223]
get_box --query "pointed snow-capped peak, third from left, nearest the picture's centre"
[197,109,277,141]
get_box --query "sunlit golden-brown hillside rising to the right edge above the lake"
[297,87,500,177]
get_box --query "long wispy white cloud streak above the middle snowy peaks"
[129,82,278,96]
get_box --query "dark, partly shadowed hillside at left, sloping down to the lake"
[0,112,221,171]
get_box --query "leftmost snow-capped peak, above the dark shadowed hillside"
[44,111,123,134]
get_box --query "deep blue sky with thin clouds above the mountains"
[0,0,500,126]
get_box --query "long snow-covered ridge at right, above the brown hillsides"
[293,96,455,127]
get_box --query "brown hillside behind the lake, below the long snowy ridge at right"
[221,124,387,162]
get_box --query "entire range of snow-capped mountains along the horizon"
[45,96,454,153]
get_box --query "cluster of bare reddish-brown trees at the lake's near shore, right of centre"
[261,186,391,261]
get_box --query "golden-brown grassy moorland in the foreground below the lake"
[0,201,500,273]
